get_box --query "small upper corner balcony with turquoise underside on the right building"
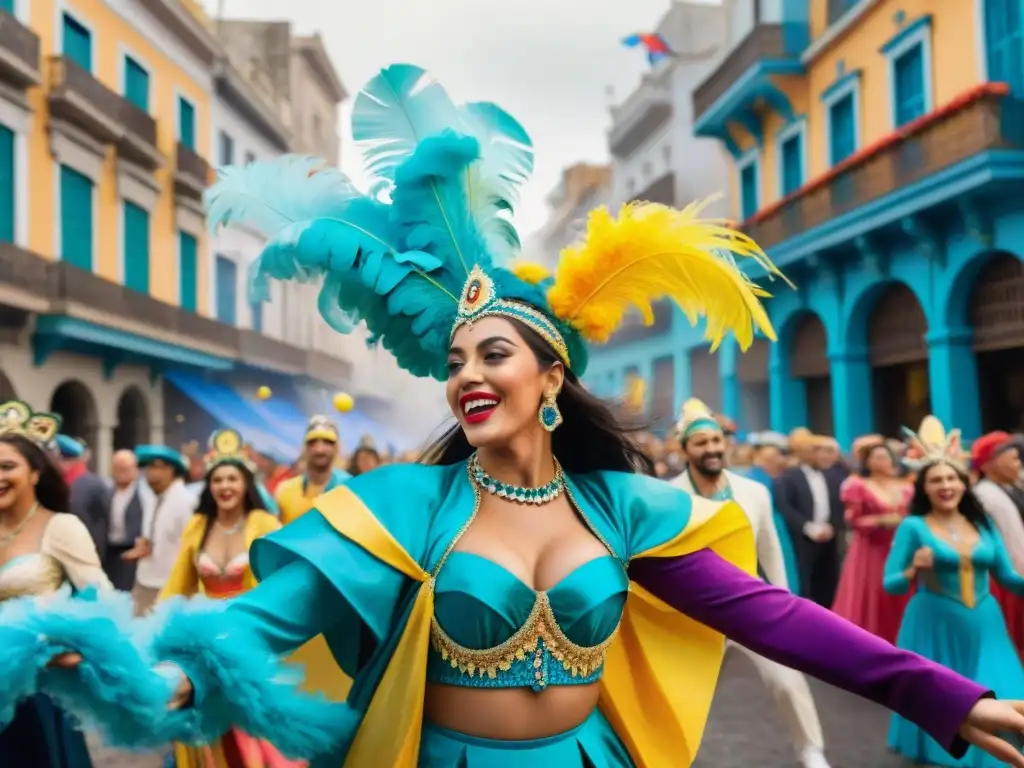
[693,23,805,148]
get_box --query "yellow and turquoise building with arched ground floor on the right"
[585,0,1024,445]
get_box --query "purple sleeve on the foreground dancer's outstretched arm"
[630,550,991,758]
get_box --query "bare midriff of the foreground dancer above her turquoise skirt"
[425,683,598,741]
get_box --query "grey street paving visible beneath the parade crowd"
[90,653,902,768]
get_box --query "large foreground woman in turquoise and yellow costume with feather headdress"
[6,65,1024,768]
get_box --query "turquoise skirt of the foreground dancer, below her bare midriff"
[419,710,634,768]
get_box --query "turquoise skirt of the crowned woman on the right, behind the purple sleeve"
[889,593,1024,768]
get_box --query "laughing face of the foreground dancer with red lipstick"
[445,317,564,449]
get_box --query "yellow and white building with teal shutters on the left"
[0,0,372,470]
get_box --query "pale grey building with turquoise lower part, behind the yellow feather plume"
[587,0,730,434]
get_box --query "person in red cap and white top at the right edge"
[971,432,1024,652]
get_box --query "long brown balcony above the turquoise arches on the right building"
[742,83,1024,260]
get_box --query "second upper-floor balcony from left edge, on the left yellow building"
[49,56,124,144]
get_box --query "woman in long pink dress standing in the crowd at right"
[833,436,913,643]
